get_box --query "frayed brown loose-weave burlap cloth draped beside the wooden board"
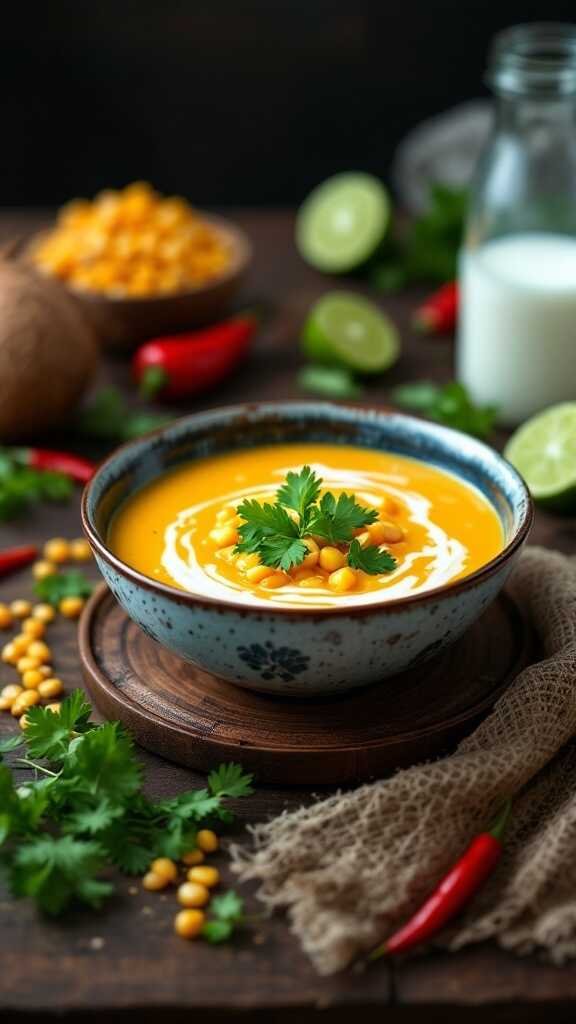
[233,548,576,974]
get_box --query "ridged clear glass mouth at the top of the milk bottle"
[486,22,576,98]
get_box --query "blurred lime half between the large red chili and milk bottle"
[302,292,400,374]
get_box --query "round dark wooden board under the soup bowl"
[80,587,531,785]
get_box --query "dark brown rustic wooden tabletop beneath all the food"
[0,205,576,1024]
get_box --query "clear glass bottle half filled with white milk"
[457,24,576,425]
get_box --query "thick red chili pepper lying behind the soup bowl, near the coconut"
[132,313,257,398]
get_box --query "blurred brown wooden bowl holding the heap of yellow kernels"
[19,212,252,351]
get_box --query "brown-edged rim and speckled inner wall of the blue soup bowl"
[81,398,534,620]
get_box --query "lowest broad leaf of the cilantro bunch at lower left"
[9,834,112,914]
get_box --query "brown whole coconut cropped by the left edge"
[0,258,98,441]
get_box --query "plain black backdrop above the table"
[0,0,576,206]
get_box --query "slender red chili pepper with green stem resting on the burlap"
[370,801,510,959]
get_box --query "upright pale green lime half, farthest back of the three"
[296,172,389,273]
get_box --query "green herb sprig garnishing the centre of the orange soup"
[235,466,396,575]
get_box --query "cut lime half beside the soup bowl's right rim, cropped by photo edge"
[504,401,576,512]
